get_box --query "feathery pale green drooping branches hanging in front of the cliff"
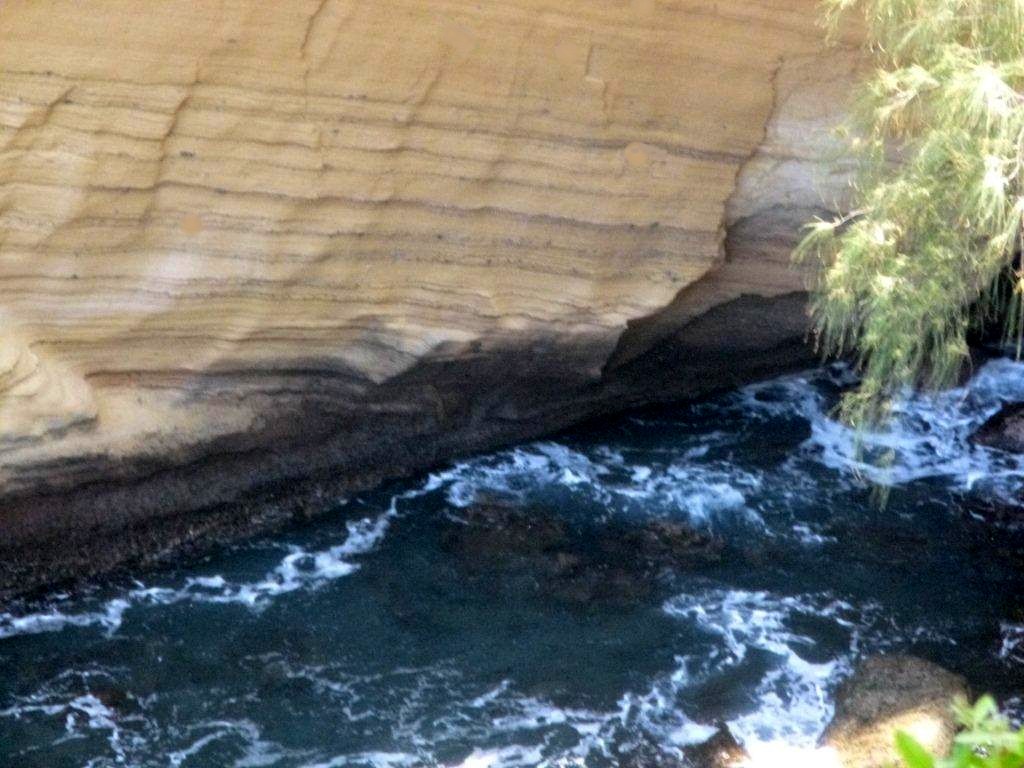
[797,0,1024,425]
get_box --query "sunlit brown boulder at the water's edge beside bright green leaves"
[822,655,970,768]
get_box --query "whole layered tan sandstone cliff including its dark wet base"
[0,0,856,592]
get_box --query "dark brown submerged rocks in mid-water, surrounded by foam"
[441,502,723,606]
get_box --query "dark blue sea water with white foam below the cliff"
[0,360,1024,768]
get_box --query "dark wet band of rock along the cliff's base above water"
[0,294,814,600]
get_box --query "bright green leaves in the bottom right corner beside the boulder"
[896,696,1024,768]
